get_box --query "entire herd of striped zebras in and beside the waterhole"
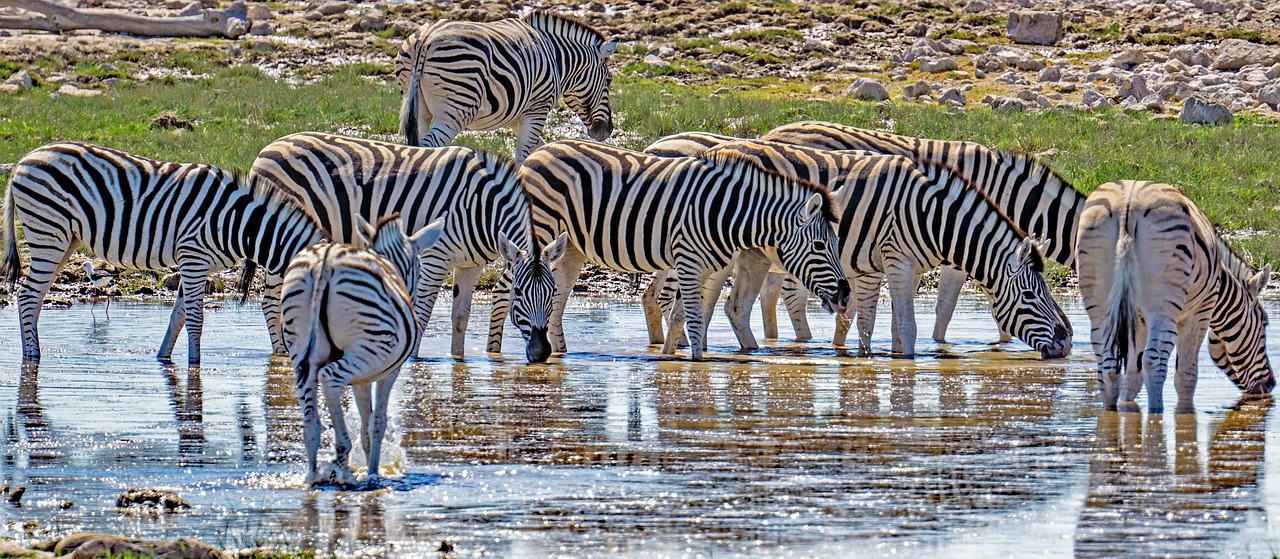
[0,12,1275,484]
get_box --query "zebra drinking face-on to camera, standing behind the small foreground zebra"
[250,132,564,362]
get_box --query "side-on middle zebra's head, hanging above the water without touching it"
[778,192,850,313]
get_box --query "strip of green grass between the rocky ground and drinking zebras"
[0,65,1280,265]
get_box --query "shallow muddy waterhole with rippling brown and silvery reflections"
[0,298,1280,558]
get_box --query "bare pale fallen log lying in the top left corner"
[0,0,248,38]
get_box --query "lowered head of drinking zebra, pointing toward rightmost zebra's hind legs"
[988,237,1071,359]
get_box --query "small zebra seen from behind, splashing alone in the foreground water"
[282,214,444,486]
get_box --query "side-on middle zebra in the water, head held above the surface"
[494,141,849,359]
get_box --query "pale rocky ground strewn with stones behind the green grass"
[0,0,1280,117]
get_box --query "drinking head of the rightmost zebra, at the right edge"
[1208,266,1276,394]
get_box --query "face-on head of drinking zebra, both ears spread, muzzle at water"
[499,234,568,363]
